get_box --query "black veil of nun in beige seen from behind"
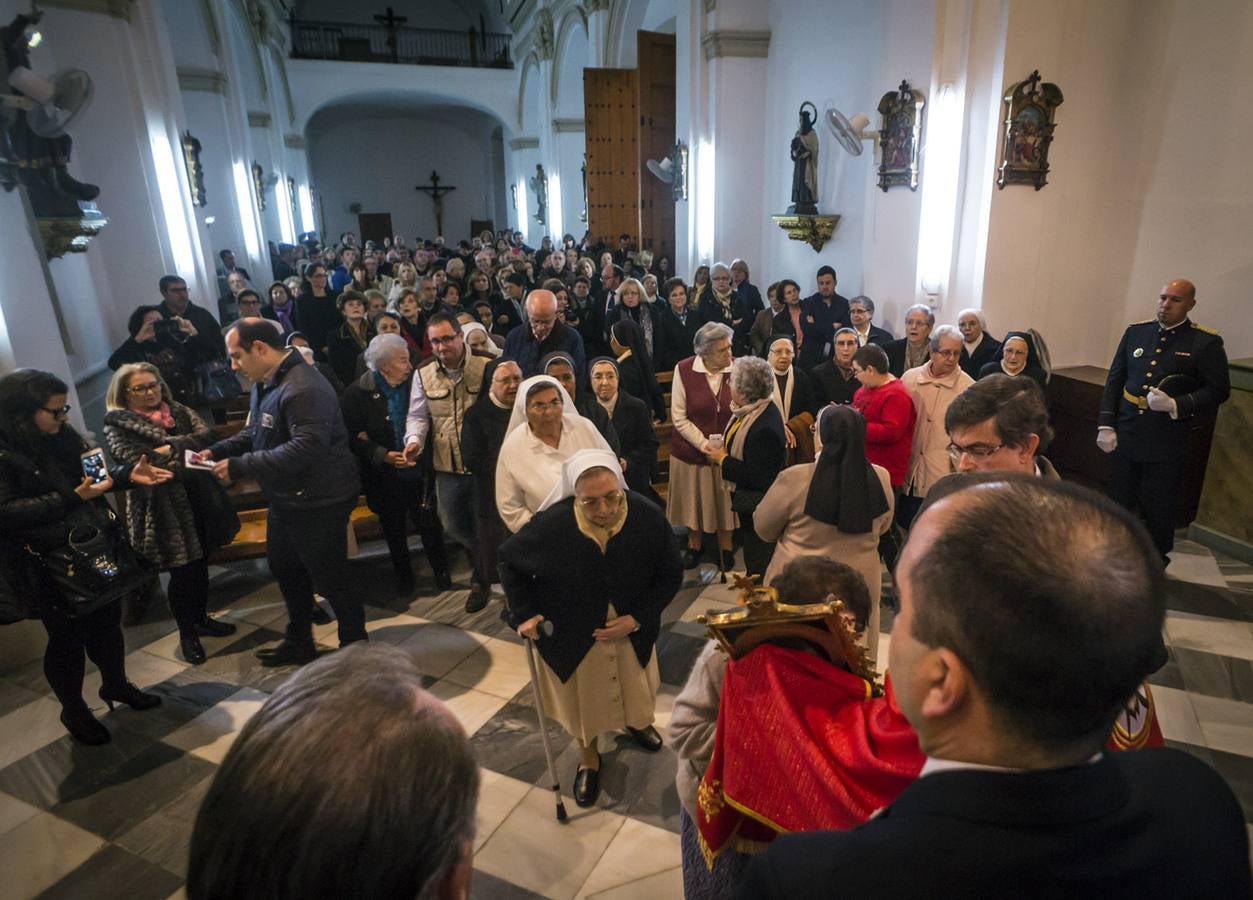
[804,405,887,534]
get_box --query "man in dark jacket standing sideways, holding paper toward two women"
[198,318,366,666]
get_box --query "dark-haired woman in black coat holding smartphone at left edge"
[0,369,174,743]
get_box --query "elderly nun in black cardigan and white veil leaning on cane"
[500,450,683,807]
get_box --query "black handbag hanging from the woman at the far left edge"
[26,503,155,619]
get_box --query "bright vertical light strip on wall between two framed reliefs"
[918,84,962,297]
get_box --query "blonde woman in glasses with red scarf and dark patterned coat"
[104,362,239,666]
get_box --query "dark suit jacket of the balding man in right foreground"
[739,748,1249,900]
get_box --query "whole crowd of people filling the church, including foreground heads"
[0,220,1247,897]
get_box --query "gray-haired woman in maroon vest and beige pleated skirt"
[665,322,736,569]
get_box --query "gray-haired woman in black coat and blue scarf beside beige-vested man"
[340,333,452,599]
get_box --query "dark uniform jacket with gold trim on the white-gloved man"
[1098,318,1232,461]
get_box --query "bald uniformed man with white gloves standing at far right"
[1096,278,1232,564]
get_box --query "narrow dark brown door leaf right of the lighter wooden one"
[635,31,675,256]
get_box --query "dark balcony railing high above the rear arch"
[292,19,514,69]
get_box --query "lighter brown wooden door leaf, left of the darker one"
[583,69,639,247]
